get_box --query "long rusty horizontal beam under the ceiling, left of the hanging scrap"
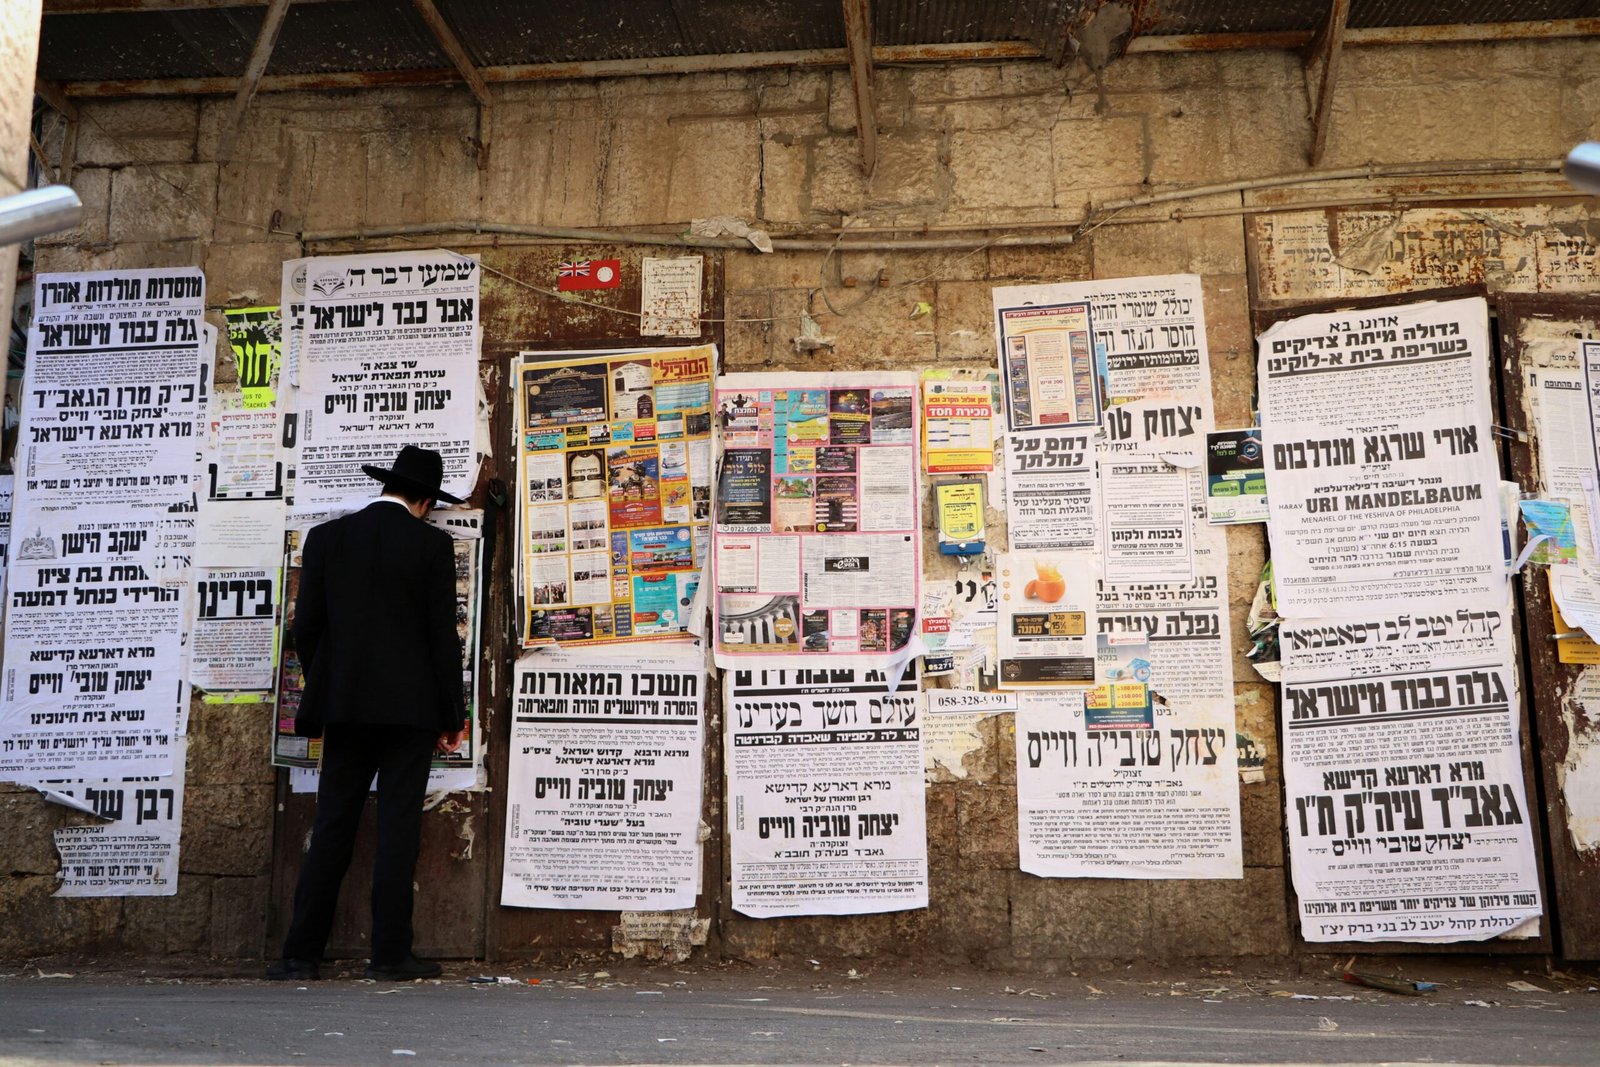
[62,41,1038,98]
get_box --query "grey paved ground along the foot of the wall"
[0,960,1600,1067]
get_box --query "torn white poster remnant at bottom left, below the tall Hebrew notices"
[45,739,184,897]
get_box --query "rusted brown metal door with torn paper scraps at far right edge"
[1496,294,1600,960]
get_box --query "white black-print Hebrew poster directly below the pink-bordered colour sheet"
[723,661,928,918]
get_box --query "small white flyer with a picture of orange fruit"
[995,550,1101,689]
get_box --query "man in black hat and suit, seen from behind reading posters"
[267,445,467,981]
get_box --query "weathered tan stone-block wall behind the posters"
[15,42,1600,966]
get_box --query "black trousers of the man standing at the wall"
[283,725,438,965]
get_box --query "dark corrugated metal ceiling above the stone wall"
[34,0,1600,82]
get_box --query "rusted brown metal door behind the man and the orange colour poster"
[267,243,723,960]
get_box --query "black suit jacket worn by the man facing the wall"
[293,501,466,737]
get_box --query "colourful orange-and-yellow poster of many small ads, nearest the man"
[515,346,717,645]
